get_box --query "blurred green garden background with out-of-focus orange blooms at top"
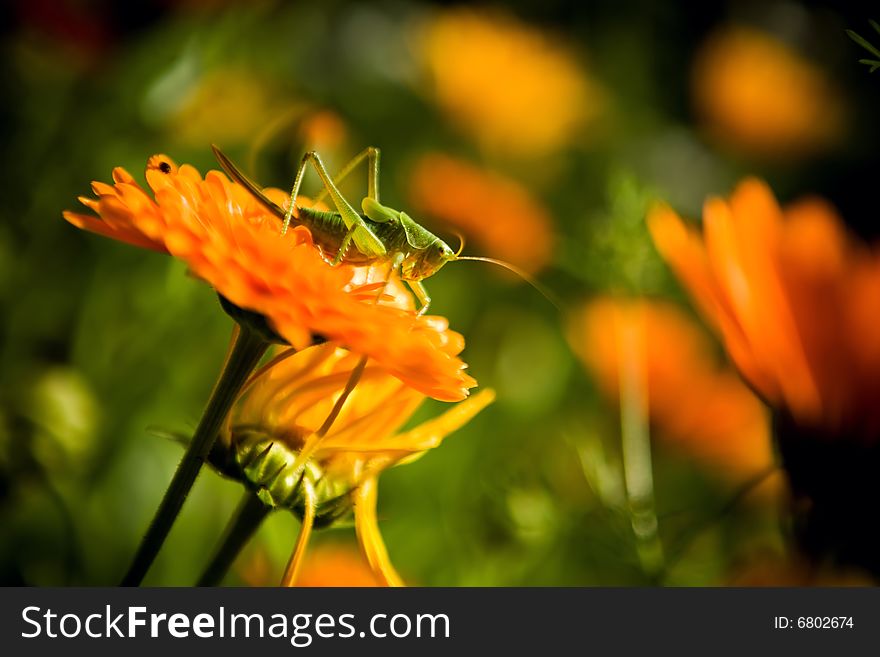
[0,0,880,586]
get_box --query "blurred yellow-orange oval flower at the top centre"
[418,8,604,156]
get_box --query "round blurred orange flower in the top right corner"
[692,26,844,157]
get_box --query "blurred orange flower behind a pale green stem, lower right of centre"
[572,298,773,478]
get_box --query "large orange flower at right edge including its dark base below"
[649,180,880,577]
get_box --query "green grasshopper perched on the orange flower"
[212,146,460,314]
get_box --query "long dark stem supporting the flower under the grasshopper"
[121,326,268,586]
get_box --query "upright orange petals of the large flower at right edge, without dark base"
[648,179,880,437]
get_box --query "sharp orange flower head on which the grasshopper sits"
[64,155,476,401]
